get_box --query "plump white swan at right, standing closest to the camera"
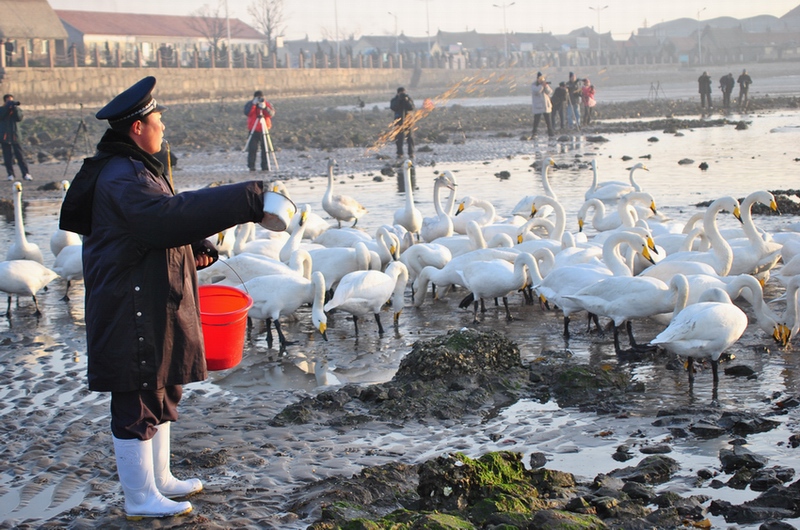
[650,288,747,387]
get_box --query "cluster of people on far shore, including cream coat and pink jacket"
[531,72,596,137]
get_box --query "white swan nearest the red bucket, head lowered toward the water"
[244,272,328,351]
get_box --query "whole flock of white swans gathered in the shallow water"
[0,155,800,385]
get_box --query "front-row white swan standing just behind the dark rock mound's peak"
[458,252,539,324]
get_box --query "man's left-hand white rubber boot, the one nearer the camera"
[114,437,192,521]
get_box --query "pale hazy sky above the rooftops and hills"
[49,0,800,40]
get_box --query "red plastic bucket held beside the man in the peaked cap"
[199,285,253,370]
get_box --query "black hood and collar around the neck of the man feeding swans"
[59,129,166,236]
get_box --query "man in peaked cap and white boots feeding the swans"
[60,77,278,519]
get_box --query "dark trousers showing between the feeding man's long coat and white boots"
[111,385,183,440]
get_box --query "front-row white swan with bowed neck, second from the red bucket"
[325,261,408,335]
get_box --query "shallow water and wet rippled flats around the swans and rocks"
[0,112,800,528]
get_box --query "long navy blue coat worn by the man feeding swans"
[83,156,264,392]
